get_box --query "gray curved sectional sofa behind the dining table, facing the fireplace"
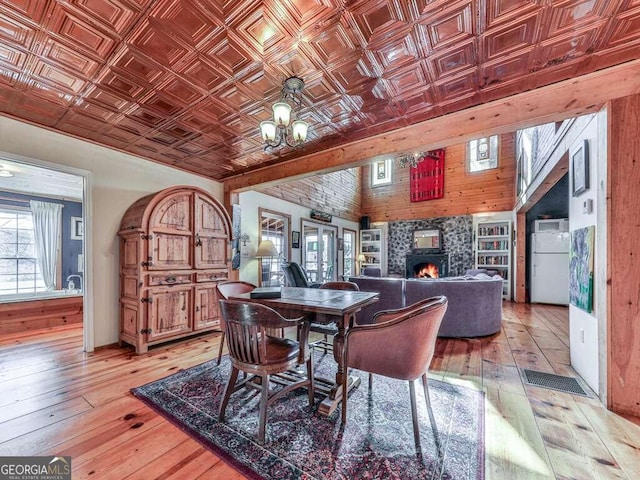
[349,274,502,337]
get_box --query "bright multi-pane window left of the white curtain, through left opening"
[0,206,46,295]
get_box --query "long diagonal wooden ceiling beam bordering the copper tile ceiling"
[224,60,640,197]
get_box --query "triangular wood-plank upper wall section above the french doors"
[256,167,362,221]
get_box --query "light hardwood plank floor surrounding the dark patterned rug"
[0,303,640,480]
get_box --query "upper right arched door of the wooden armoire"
[194,194,230,268]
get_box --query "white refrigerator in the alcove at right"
[529,231,569,305]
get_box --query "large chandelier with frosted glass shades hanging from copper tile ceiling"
[260,76,309,151]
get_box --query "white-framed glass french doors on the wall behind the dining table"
[302,220,338,283]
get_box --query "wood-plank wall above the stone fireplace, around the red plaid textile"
[362,133,516,222]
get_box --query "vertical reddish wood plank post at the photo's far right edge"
[607,95,640,416]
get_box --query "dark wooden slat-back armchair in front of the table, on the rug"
[218,300,314,443]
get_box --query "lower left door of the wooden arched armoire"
[148,287,192,341]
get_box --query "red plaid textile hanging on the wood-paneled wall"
[407,148,444,202]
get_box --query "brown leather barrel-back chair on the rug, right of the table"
[342,296,447,446]
